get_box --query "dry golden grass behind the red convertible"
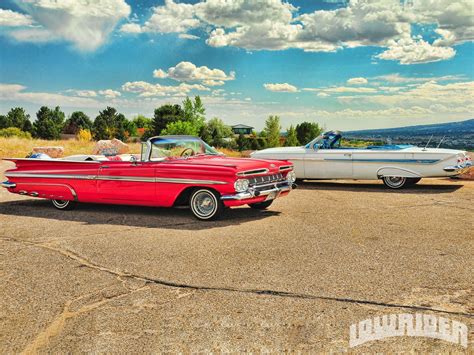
[0,137,247,159]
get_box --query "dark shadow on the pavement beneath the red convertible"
[0,199,280,230]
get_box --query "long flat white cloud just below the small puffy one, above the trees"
[122,81,210,97]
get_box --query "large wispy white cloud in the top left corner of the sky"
[12,0,130,52]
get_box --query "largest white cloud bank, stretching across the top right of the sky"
[116,0,474,64]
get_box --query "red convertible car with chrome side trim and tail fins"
[2,136,296,220]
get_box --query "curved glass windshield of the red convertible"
[150,136,220,160]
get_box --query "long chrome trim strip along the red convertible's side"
[5,172,227,185]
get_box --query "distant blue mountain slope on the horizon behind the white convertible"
[344,119,474,138]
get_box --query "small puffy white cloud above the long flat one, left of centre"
[153,62,235,86]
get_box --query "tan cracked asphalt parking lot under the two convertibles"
[0,162,474,353]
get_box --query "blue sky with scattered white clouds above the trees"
[0,0,474,130]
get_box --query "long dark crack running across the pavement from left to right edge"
[0,238,474,318]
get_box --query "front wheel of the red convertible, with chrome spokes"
[189,189,224,221]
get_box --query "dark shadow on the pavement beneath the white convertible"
[298,180,463,194]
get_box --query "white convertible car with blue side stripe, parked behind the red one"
[251,131,472,189]
